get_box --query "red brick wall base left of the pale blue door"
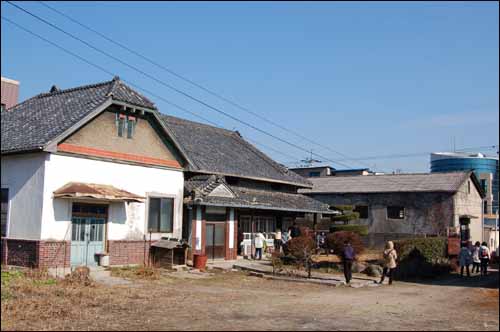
[1,238,71,268]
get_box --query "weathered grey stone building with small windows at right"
[300,172,484,246]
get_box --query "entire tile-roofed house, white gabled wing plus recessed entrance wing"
[1,78,333,267]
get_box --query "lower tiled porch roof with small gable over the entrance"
[184,175,333,213]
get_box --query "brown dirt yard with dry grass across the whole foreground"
[2,272,499,331]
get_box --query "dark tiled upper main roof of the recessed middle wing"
[161,115,311,187]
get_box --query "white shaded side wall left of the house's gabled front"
[1,152,49,240]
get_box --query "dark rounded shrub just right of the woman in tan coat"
[394,237,452,279]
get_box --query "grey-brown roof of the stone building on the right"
[299,172,478,194]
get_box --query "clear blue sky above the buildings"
[1,1,499,172]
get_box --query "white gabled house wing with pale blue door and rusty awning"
[1,78,186,267]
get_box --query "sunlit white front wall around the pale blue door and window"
[41,154,184,240]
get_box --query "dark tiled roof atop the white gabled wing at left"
[1,77,156,153]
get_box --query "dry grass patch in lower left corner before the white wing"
[1,270,146,330]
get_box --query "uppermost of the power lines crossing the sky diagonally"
[38,1,371,167]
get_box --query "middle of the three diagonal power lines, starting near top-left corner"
[6,1,351,168]
